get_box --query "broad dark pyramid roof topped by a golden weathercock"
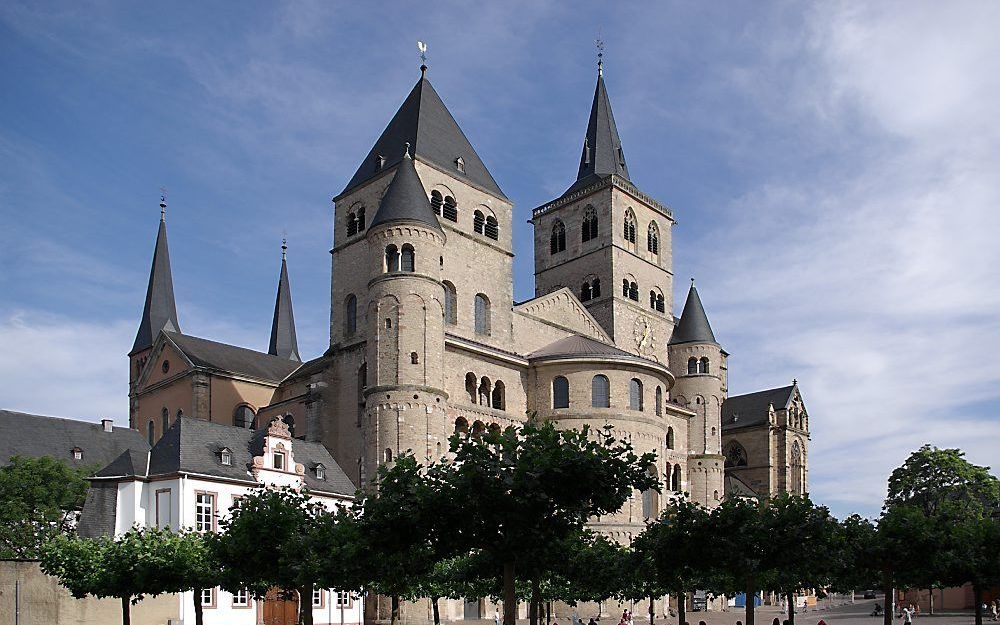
[341,72,507,200]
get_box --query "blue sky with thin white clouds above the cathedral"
[0,0,1000,516]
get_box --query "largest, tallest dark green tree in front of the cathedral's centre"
[429,419,659,625]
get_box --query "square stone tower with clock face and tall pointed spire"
[531,64,674,362]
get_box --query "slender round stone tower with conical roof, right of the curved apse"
[668,279,729,505]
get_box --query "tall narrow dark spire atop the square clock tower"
[566,69,629,193]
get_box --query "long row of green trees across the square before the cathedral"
[35,422,1000,625]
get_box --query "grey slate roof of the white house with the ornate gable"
[98,417,356,496]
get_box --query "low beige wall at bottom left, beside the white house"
[0,560,179,625]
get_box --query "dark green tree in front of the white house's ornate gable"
[211,488,330,625]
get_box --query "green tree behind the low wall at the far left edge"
[0,456,92,559]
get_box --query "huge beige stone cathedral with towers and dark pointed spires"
[129,61,809,542]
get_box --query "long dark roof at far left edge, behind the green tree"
[0,410,149,467]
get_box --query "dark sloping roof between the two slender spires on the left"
[164,332,302,383]
